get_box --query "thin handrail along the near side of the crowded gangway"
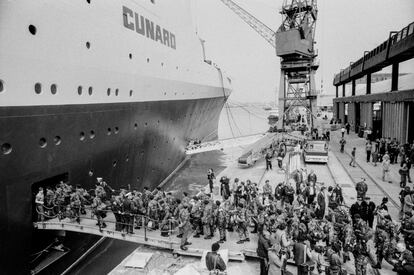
[35,205,179,250]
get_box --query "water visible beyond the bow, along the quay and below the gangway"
[56,106,269,274]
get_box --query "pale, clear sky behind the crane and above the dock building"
[192,0,414,102]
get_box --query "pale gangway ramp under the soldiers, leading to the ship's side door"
[33,209,249,261]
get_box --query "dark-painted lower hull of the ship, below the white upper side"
[0,96,225,273]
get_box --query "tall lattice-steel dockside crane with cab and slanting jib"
[220,0,318,132]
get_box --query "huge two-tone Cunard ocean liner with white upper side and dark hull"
[0,0,231,274]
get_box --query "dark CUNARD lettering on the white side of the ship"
[122,6,176,50]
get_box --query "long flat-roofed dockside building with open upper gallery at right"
[333,22,414,143]
